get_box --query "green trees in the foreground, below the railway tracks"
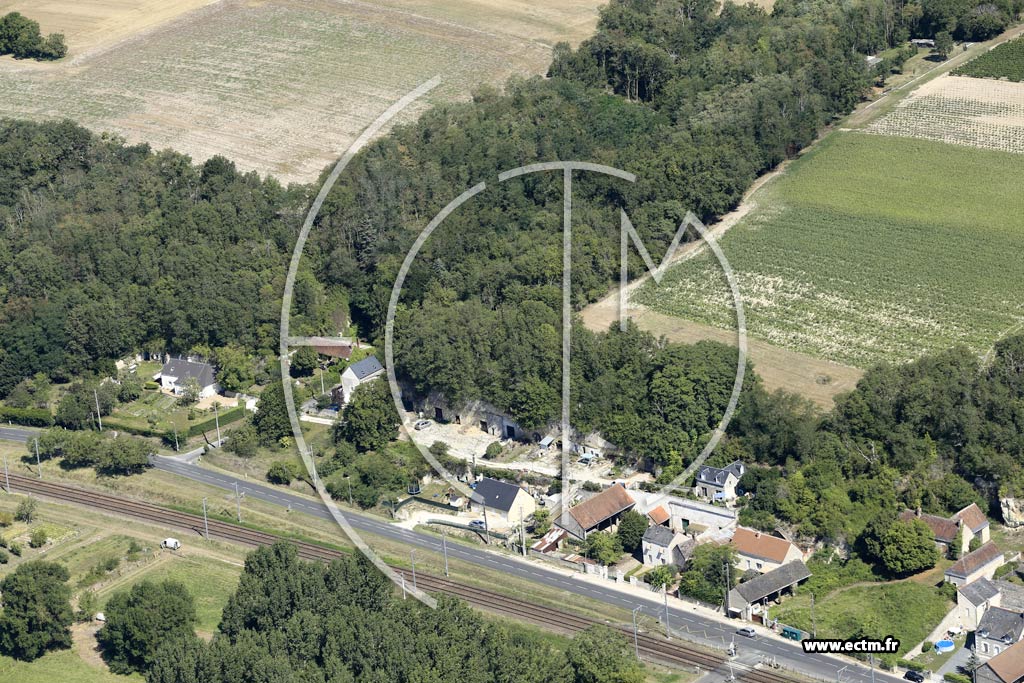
[0,543,646,683]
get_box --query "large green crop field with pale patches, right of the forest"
[634,132,1024,368]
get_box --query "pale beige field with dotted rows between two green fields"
[865,76,1024,154]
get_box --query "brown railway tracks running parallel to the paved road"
[2,474,799,683]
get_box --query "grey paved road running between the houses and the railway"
[148,459,899,683]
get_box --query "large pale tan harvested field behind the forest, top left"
[0,0,603,182]
